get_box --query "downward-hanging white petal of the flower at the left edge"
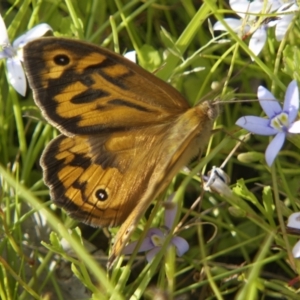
[6,57,27,96]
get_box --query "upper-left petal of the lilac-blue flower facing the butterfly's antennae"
[257,86,282,119]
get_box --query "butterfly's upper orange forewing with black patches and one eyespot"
[24,38,188,135]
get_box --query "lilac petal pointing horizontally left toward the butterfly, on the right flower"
[235,116,278,135]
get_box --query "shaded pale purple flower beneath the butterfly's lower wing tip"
[122,196,189,262]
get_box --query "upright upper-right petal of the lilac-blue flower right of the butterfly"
[283,80,299,123]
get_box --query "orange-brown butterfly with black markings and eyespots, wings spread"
[24,37,218,264]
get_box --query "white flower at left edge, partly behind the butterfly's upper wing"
[0,15,52,96]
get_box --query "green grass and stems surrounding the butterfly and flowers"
[0,0,300,300]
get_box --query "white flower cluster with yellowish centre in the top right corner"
[213,0,299,55]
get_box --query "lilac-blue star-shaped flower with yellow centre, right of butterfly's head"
[236,80,300,166]
